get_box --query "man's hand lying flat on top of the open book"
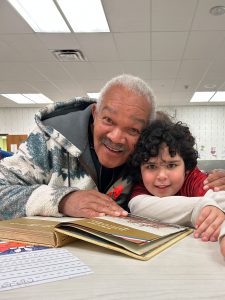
[59,190,128,218]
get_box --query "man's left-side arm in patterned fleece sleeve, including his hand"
[0,130,127,219]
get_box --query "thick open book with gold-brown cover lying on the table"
[0,214,193,260]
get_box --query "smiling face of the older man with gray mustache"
[92,86,151,168]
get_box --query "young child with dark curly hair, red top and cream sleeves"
[129,120,225,252]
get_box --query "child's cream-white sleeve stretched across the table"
[129,190,225,227]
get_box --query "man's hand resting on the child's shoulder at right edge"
[203,169,225,192]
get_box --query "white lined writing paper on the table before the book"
[0,248,93,291]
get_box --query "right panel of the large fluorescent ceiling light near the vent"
[57,0,110,32]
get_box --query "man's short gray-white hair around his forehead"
[97,74,155,123]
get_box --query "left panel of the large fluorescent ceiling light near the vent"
[8,0,70,32]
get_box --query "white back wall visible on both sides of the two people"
[0,106,225,159]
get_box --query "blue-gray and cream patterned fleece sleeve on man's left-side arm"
[0,128,77,219]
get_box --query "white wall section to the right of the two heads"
[158,106,225,159]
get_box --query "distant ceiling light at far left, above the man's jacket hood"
[1,94,53,104]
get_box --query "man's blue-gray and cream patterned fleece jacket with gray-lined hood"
[0,98,131,219]
